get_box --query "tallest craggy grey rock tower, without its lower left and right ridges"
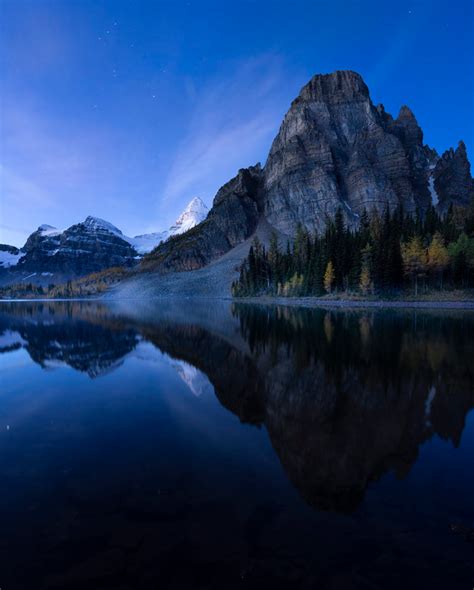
[264,71,436,234]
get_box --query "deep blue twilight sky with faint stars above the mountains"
[0,0,474,246]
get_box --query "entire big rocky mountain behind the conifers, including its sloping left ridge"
[142,71,474,272]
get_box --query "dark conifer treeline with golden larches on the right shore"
[232,207,474,297]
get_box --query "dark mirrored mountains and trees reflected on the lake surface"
[0,302,474,512]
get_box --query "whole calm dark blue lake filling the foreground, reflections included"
[0,302,474,590]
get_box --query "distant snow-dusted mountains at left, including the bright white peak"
[0,197,208,284]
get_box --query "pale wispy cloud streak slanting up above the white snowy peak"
[161,56,288,221]
